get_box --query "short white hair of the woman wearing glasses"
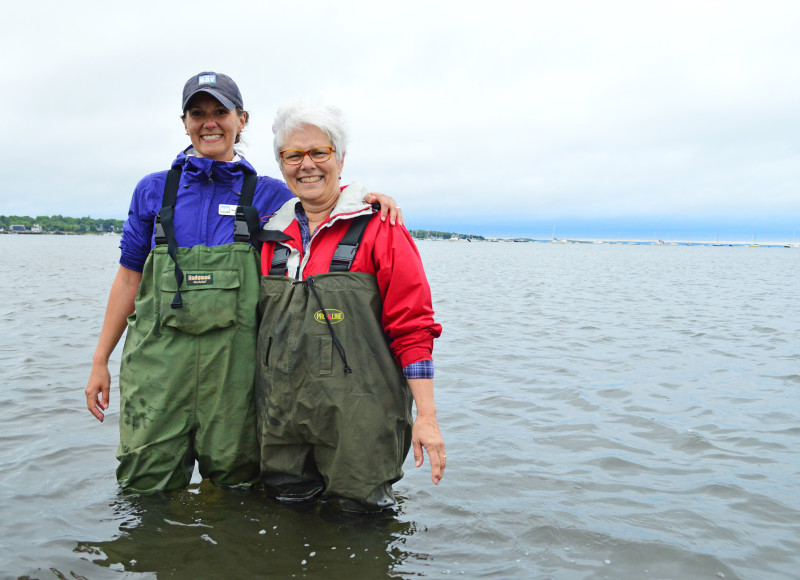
[272,100,347,164]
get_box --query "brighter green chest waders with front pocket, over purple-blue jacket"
[117,171,260,491]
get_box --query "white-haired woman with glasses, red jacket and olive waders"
[256,104,446,511]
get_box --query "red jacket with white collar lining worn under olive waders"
[261,184,442,367]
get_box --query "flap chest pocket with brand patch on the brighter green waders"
[160,270,239,334]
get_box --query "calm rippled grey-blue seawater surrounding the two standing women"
[0,235,800,580]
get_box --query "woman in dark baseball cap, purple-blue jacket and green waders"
[85,72,402,492]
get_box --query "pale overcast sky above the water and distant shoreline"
[0,0,800,236]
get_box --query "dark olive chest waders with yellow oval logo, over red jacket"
[256,216,412,510]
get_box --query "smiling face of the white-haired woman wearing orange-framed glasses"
[281,125,344,209]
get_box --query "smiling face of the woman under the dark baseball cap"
[183,93,247,161]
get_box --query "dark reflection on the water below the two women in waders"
[74,482,418,578]
